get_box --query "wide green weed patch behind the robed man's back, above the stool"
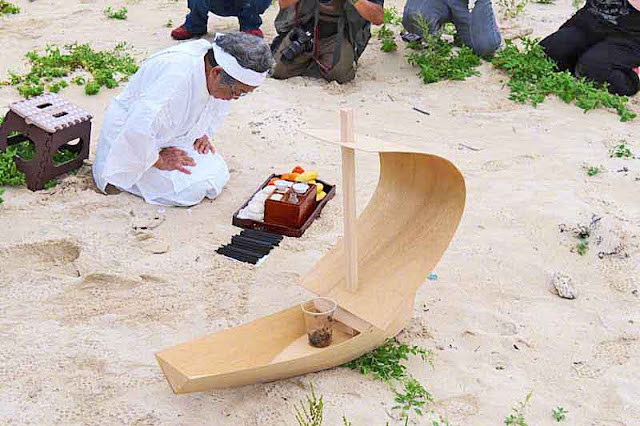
[3,43,138,98]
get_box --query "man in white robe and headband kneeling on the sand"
[93,33,273,206]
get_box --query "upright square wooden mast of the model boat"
[340,109,358,292]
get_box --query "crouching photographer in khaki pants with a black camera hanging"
[271,0,384,83]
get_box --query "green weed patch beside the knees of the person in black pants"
[492,38,636,122]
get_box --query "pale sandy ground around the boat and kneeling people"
[0,0,640,426]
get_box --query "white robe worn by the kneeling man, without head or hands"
[93,40,229,206]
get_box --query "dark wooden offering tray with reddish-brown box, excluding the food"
[232,174,336,238]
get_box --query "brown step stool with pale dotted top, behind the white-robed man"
[0,94,93,191]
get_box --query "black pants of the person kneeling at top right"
[540,9,640,96]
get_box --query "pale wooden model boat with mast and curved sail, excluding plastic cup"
[156,111,465,393]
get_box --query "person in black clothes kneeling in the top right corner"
[541,0,640,96]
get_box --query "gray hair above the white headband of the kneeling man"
[214,33,274,73]
